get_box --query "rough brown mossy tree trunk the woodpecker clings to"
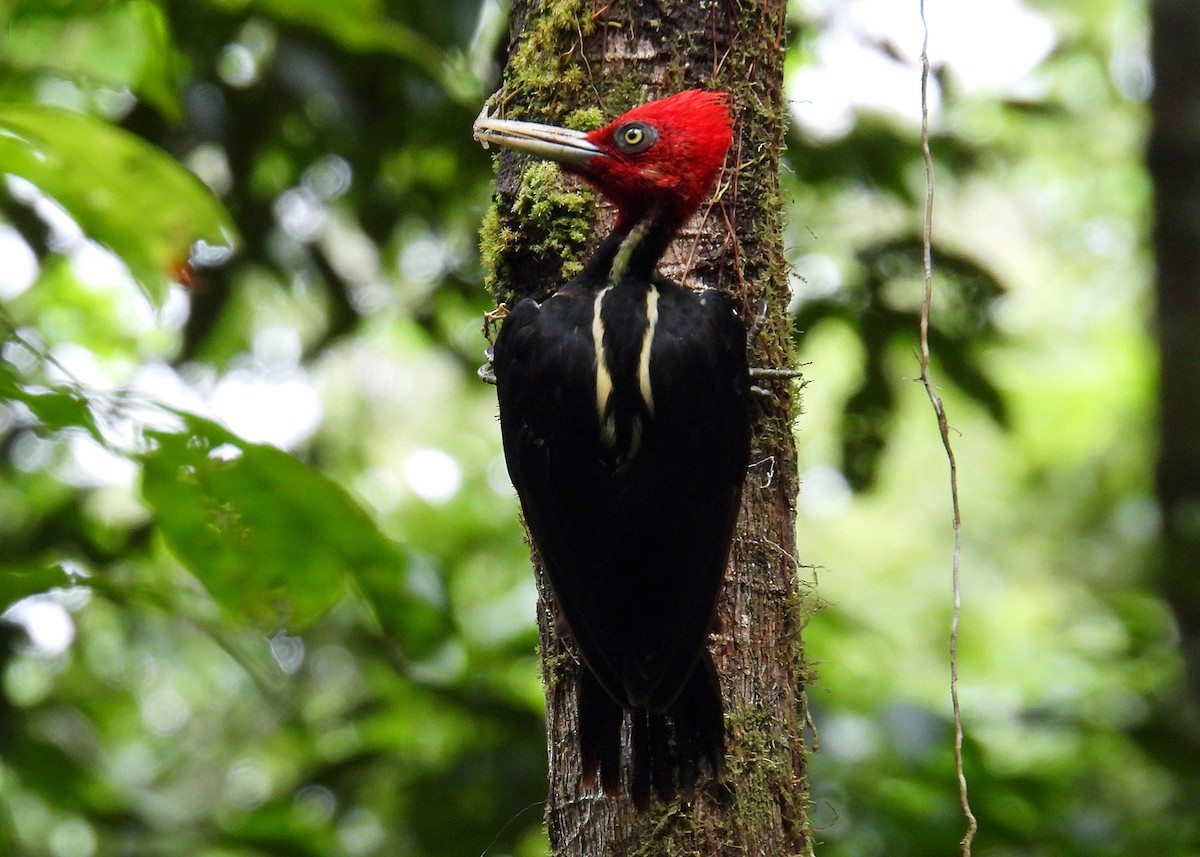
[482,0,808,857]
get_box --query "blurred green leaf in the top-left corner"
[0,0,182,121]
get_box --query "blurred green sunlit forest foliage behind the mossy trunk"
[0,0,1200,857]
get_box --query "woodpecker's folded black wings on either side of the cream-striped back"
[494,283,749,711]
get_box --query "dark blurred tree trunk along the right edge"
[1147,0,1200,702]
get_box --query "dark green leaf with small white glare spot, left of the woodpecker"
[142,414,440,649]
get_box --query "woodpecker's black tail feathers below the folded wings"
[580,652,725,809]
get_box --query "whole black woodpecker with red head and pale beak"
[474,90,750,809]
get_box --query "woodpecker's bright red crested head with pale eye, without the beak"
[566,89,733,228]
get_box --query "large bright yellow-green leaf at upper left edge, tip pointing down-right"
[0,103,236,302]
